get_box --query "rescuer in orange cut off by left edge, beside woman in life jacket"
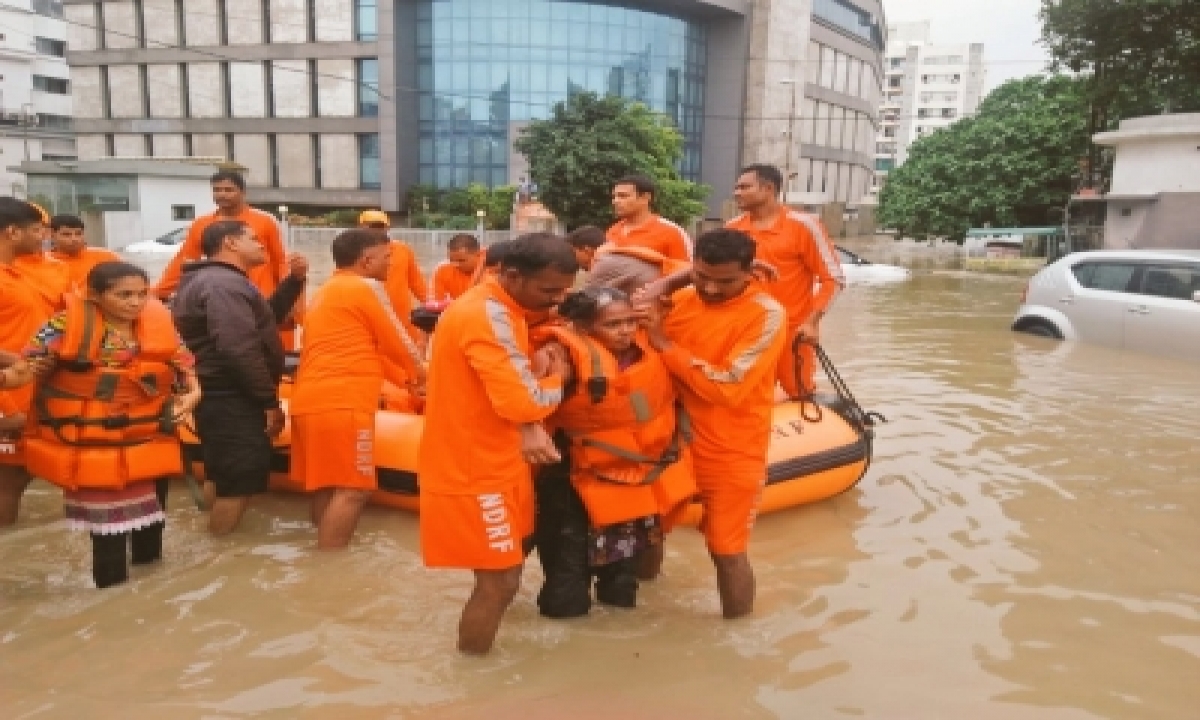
[0,197,71,527]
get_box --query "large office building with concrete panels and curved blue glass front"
[65,0,884,214]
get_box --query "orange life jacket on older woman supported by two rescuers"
[533,325,696,527]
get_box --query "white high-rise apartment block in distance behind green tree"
[875,20,986,191]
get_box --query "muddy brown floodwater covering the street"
[0,238,1200,720]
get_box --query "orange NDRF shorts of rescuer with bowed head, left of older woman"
[421,480,534,570]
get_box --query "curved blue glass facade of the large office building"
[416,0,707,187]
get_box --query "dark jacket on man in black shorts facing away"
[170,260,305,409]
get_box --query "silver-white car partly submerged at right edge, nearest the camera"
[1013,250,1200,360]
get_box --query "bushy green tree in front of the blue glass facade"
[514,92,708,228]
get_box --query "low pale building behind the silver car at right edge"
[1094,113,1200,250]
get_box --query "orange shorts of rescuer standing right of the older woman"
[696,468,767,556]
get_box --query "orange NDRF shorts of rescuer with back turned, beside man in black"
[292,410,379,492]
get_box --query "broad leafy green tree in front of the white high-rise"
[878,76,1088,239]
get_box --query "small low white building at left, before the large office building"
[19,158,223,250]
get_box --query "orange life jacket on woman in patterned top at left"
[25,298,182,490]
